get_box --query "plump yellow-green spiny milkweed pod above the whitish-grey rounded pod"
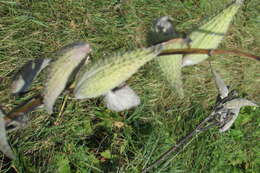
[74,45,161,99]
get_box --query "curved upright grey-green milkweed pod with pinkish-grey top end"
[43,42,91,114]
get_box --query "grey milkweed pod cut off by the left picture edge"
[0,110,15,159]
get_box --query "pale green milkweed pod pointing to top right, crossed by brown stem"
[182,0,243,66]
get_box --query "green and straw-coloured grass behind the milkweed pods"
[0,0,260,173]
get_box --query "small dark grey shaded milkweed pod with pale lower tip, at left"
[11,58,51,94]
